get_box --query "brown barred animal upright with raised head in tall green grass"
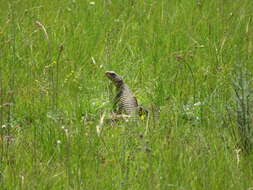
[105,71,148,117]
